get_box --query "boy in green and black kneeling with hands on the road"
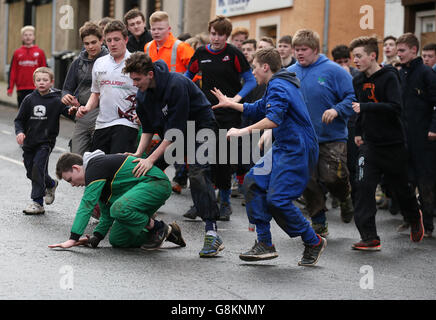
[49,150,186,250]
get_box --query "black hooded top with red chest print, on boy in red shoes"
[353,66,404,145]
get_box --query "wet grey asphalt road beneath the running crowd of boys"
[0,106,436,300]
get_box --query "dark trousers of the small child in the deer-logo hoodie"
[23,144,54,200]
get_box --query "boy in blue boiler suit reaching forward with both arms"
[212,49,327,266]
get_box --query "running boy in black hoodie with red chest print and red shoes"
[350,37,424,251]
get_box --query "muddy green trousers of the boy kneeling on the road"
[107,180,171,248]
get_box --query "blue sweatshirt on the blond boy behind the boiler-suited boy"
[287,54,355,143]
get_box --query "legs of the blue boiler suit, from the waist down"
[244,149,319,245]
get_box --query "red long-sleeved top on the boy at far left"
[8,45,47,93]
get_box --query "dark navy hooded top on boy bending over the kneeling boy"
[136,60,215,138]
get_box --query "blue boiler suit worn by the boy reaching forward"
[243,69,319,245]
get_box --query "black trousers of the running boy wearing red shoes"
[354,144,419,240]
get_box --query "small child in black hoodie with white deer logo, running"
[15,67,70,214]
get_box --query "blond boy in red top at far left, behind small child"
[8,26,47,108]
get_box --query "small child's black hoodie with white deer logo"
[14,89,72,149]
